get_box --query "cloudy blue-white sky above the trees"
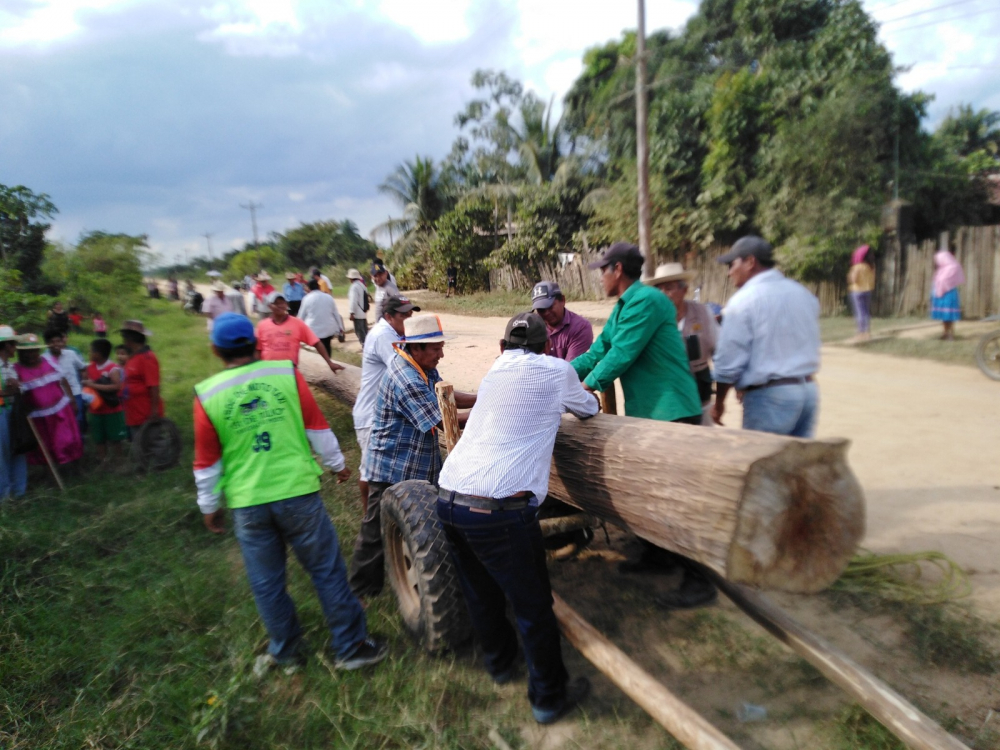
[0,0,1000,268]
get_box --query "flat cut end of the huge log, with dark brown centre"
[726,440,865,593]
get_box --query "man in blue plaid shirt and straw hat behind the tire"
[350,315,476,597]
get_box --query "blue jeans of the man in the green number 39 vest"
[233,492,367,662]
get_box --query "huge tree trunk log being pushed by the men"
[300,356,864,593]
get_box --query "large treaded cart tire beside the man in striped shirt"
[381,480,472,653]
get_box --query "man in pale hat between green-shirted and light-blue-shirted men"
[644,263,719,426]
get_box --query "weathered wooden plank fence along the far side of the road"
[490,226,1000,318]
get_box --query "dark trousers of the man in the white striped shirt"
[440,499,568,709]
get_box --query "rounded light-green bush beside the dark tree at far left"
[45,232,149,317]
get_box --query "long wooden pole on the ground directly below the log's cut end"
[715,577,969,750]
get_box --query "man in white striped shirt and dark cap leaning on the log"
[437,313,598,724]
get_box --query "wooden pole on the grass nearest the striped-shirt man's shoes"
[552,592,739,750]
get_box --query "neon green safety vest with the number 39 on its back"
[194,360,323,508]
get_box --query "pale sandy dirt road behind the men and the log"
[337,299,1000,619]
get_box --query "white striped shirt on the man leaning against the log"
[439,349,597,505]
